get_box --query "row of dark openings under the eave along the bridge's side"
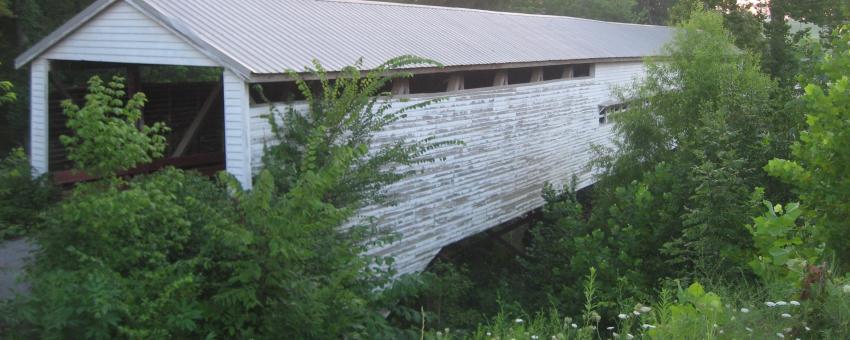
[251,64,594,103]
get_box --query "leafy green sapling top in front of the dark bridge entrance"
[60,77,168,176]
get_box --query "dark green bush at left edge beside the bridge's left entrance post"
[0,149,55,240]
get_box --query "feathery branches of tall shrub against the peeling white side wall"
[263,56,459,208]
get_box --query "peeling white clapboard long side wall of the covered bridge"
[251,62,645,274]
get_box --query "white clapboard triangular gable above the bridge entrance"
[44,1,218,66]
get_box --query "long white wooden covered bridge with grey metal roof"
[15,0,672,273]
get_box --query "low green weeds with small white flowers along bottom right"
[424,280,850,340]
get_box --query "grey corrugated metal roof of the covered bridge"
[14,0,673,76]
